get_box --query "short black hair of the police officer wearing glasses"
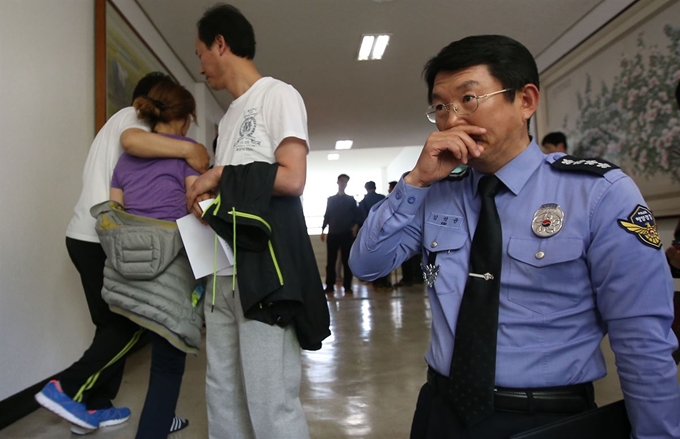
[423,35,539,104]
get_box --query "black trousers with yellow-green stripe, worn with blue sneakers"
[59,238,142,410]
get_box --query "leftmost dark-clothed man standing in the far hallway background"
[321,174,360,294]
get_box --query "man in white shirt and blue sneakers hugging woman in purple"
[35,72,209,434]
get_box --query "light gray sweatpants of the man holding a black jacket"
[204,276,309,439]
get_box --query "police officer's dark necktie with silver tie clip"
[450,175,503,426]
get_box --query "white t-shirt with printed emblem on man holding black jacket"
[215,77,309,165]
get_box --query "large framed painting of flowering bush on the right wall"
[537,0,680,217]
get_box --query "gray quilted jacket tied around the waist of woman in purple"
[90,201,203,354]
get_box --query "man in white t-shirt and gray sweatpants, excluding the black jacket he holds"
[187,4,323,439]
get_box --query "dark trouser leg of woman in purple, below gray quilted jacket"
[136,333,186,439]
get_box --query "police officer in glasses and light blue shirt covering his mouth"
[350,35,680,439]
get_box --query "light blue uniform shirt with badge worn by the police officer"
[350,142,680,438]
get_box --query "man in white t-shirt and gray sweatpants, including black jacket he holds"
[187,4,330,439]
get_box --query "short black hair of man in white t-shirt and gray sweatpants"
[201,3,255,59]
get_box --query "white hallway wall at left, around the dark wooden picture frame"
[0,0,222,400]
